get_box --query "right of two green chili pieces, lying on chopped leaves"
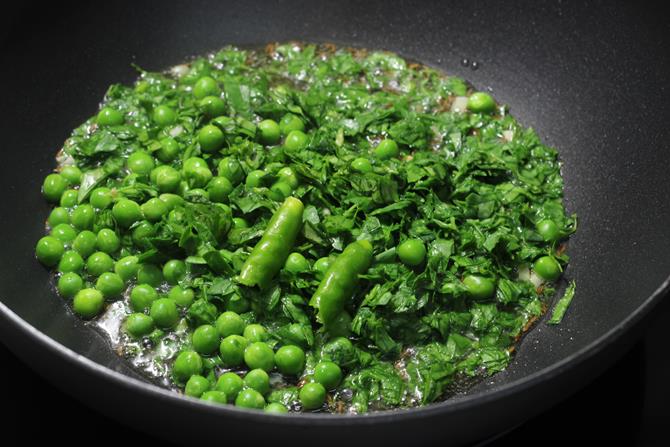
[309,240,372,324]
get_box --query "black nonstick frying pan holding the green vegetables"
[0,1,670,445]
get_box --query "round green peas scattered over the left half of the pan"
[35,72,368,413]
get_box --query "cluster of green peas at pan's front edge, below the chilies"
[172,318,342,413]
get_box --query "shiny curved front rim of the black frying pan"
[0,275,670,426]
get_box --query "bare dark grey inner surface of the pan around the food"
[0,1,670,412]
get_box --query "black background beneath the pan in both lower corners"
[0,297,670,446]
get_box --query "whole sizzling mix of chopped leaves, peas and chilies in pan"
[36,43,576,413]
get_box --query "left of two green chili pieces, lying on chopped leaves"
[238,197,304,288]
